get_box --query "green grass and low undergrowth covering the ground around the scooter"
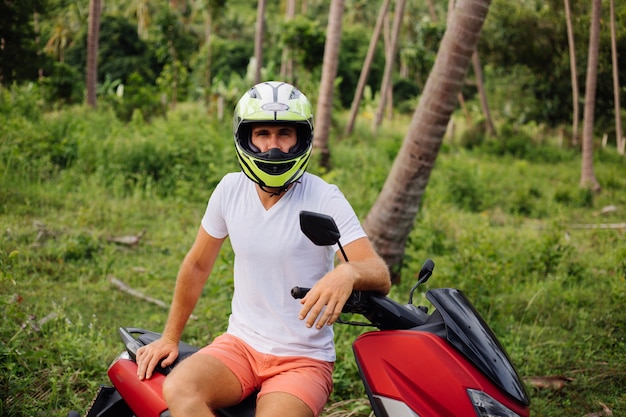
[0,102,626,416]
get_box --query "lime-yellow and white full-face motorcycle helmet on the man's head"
[233,81,313,193]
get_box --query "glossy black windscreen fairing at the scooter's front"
[426,288,530,405]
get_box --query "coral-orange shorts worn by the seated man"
[198,333,334,416]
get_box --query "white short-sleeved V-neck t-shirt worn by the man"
[202,172,366,362]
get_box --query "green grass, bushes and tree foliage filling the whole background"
[0,0,626,417]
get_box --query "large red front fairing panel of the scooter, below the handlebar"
[353,330,529,417]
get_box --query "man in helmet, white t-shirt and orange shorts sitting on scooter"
[137,82,391,417]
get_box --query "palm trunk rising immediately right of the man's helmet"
[313,0,344,168]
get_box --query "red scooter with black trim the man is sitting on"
[69,212,530,417]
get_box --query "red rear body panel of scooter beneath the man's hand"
[108,359,167,417]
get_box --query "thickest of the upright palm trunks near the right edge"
[580,0,602,192]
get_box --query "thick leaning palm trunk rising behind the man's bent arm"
[364,0,491,282]
